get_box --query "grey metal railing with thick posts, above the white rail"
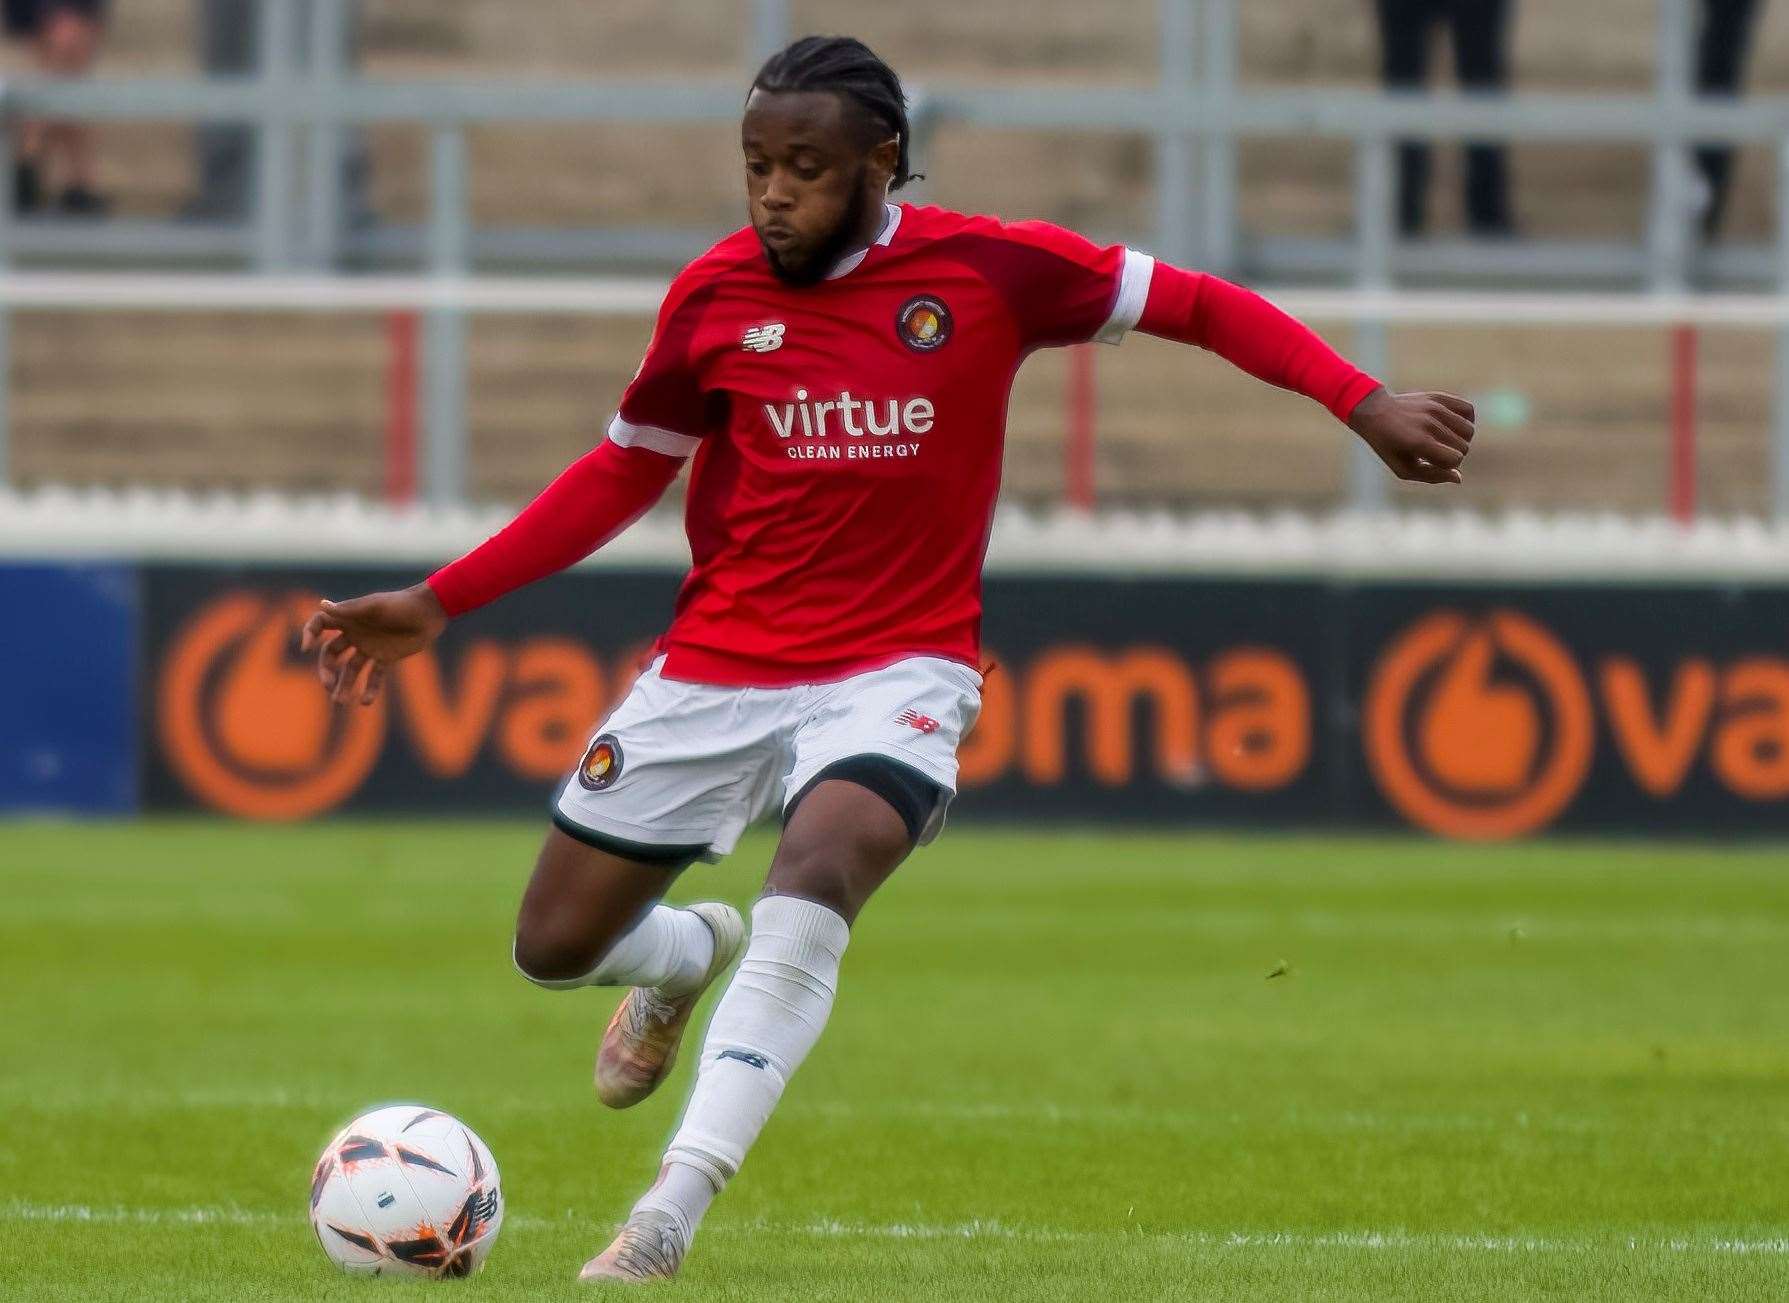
[0,0,1789,514]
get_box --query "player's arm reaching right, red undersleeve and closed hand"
[1138,263,1474,483]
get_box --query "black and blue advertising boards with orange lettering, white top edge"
[0,496,1789,839]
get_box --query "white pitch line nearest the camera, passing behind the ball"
[0,1201,1789,1256]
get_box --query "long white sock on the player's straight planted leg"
[635,897,852,1235]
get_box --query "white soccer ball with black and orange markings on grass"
[311,1104,503,1278]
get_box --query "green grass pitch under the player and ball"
[0,822,1789,1301]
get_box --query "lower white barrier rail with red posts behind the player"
[0,272,1789,523]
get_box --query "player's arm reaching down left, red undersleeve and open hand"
[302,442,682,705]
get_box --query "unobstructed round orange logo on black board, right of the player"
[1363,610,1596,839]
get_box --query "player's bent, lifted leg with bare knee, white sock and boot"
[515,829,746,1108]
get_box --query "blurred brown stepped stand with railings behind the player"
[0,0,1789,515]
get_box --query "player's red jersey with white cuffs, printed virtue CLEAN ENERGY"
[608,204,1372,687]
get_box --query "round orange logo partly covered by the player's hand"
[156,592,385,820]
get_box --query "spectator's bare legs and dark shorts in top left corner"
[4,0,106,217]
